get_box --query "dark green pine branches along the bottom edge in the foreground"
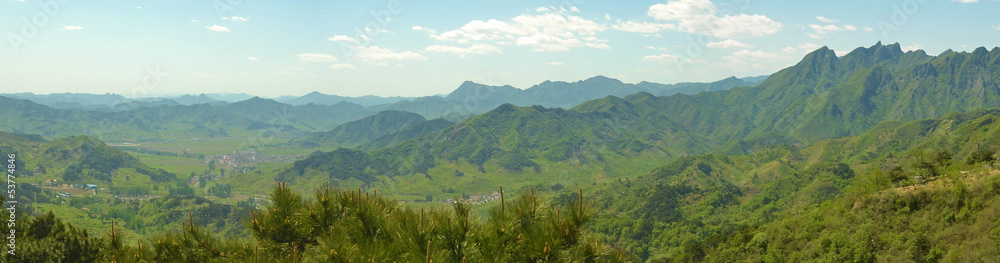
[0,184,632,262]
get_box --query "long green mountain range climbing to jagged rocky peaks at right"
[288,43,1000,195]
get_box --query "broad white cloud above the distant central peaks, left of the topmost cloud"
[431,13,610,52]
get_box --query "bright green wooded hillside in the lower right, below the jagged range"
[593,109,1000,262]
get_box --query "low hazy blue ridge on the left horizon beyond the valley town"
[0,97,373,141]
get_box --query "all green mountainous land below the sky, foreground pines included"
[0,43,1000,262]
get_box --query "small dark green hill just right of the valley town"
[299,110,427,148]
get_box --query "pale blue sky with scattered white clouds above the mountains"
[0,0,1000,97]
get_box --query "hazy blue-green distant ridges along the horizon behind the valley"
[0,77,760,140]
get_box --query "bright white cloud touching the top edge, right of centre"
[647,0,783,38]
